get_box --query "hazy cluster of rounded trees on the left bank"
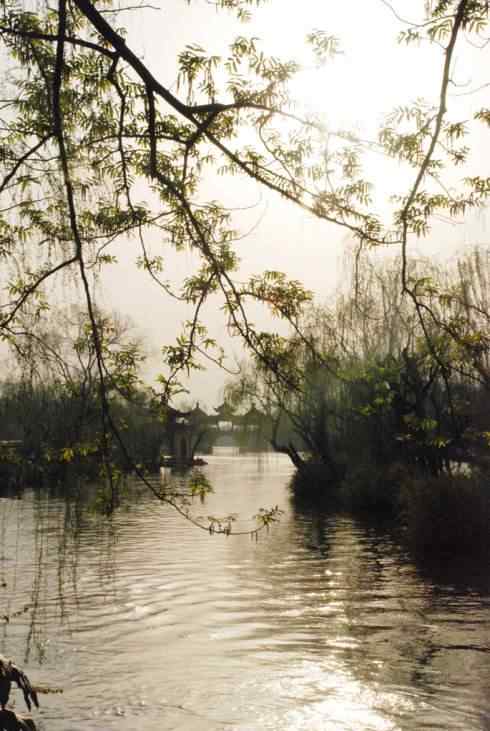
[0,308,164,484]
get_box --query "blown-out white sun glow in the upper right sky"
[249,0,442,127]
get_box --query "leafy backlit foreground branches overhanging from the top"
[0,0,490,516]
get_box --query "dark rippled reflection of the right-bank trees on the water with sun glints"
[229,497,490,716]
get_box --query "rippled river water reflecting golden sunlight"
[0,449,490,731]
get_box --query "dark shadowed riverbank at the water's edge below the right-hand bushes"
[291,464,490,556]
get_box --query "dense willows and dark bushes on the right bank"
[228,249,490,555]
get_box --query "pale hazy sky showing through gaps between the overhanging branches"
[98,0,490,408]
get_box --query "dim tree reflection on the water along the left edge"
[0,485,116,664]
